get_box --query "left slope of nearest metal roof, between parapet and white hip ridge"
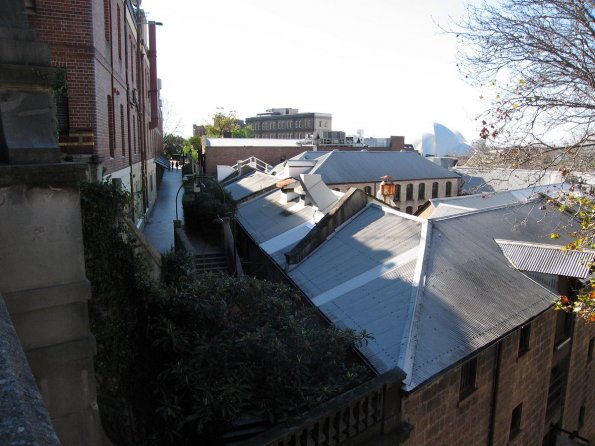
[289,204,423,372]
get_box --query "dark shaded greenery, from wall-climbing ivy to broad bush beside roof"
[81,184,369,445]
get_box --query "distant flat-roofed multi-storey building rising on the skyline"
[246,108,333,139]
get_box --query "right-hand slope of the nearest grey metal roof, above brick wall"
[405,202,569,389]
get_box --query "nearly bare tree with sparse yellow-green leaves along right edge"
[447,0,595,322]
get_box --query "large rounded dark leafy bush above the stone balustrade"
[150,268,369,444]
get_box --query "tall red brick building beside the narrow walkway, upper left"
[28,0,163,220]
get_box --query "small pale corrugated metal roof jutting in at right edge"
[496,240,595,279]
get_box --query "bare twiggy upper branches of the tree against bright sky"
[451,0,595,157]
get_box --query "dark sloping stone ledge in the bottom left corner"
[0,295,60,446]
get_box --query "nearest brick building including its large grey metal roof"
[237,179,595,446]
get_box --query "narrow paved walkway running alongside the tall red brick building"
[143,169,184,253]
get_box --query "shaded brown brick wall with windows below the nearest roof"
[403,310,595,446]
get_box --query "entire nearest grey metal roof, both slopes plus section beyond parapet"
[239,185,584,391]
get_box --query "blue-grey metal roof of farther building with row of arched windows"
[309,151,459,185]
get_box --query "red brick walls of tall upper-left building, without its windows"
[29,0,161,178]
